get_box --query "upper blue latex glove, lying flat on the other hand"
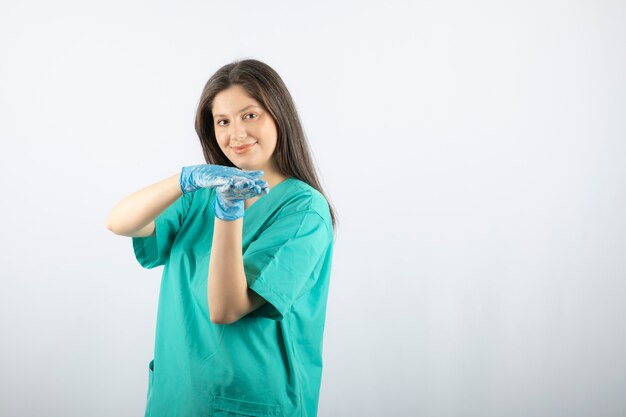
[180,164,264,194]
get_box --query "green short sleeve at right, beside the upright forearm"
[243,210,332,321]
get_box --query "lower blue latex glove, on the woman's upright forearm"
[213,177,269,221]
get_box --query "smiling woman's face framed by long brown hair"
[211,85,278,173]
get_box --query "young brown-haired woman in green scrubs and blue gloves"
[108,59,335,417]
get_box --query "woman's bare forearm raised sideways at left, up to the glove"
[107,173,182,235]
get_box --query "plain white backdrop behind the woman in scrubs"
[0,0,626,417]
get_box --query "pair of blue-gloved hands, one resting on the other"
[180,164,269,221]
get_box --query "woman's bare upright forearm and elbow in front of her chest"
[208,217,267,324]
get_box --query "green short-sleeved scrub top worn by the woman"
[132,177,333,417]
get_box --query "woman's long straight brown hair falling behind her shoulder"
[195,59,336,236]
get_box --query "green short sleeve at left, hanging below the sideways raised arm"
[132,192,194,269]
